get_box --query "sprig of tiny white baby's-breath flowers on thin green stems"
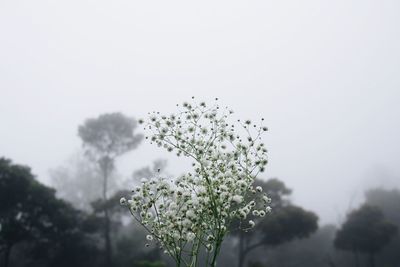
[120,98,271,267]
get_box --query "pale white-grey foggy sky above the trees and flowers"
[0,0,400,223]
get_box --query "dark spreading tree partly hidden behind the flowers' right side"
[238,179,318,267]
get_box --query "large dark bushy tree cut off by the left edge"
[0,158,98,267]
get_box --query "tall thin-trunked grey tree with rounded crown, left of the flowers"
[78,113,143,267]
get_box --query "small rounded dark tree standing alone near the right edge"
[334,205,397,267]
